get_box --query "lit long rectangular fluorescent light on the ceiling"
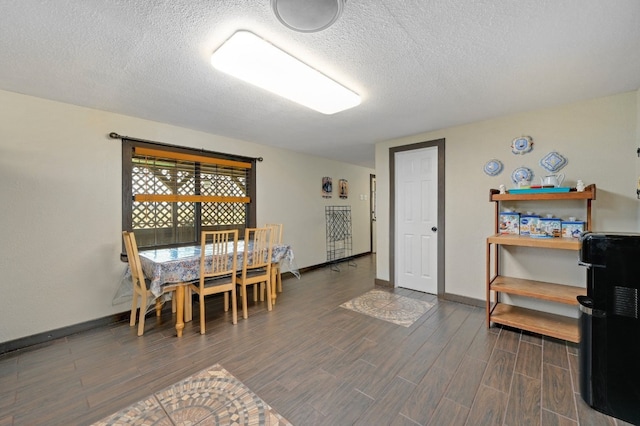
[211,31,360,114]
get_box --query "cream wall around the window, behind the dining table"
[0,91,373,343]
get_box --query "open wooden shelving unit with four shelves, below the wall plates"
[486,185,596,343]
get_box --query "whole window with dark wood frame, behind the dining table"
[122,138,256,249]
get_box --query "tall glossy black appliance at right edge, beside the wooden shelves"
[578,232,640,425]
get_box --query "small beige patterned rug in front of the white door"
[340,290,433,327]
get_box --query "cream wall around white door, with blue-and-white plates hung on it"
[376,92,640,300]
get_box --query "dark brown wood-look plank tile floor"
[0,255,626,426]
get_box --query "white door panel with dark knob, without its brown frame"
[394,146,438,294]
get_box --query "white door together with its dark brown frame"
[389,139,444,295]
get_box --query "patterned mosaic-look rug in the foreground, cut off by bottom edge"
[94,364,291,426]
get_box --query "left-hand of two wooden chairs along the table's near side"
[189,229,238,334]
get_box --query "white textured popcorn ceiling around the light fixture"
[0,0,640,167]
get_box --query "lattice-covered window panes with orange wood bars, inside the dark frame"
[131,147,252,233]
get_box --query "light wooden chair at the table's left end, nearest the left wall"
[122,231,175,336]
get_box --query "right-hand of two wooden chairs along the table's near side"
[236,227,273,319]
